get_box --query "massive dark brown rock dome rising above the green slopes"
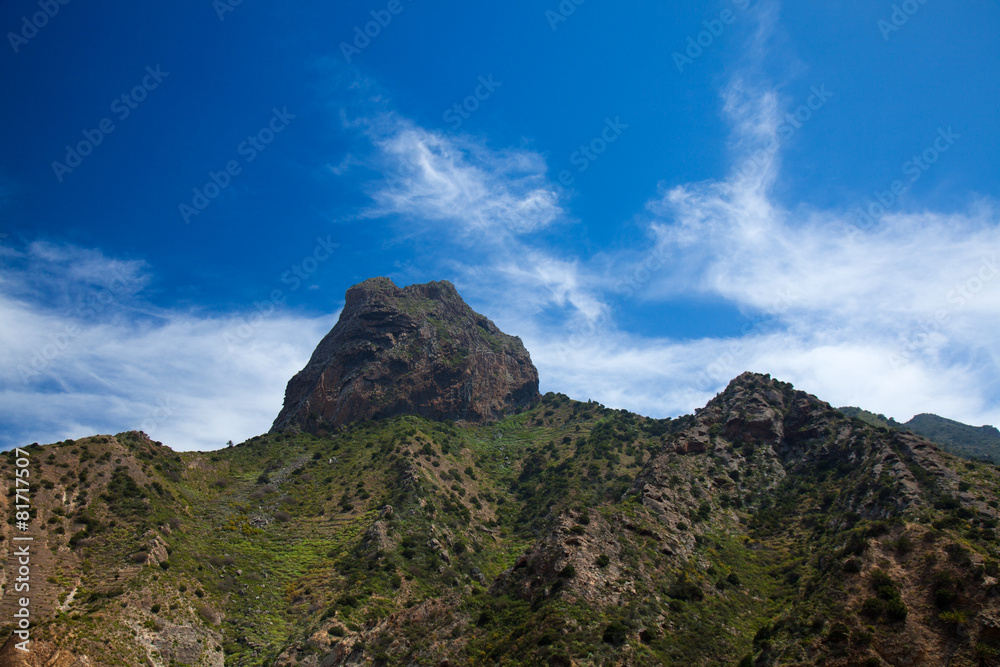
[271,278,538,433]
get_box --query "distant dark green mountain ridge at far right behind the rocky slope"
[840,407,1000,463]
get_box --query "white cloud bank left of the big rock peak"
[0,244,336,449]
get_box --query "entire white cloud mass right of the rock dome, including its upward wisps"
[344,68,1000,430]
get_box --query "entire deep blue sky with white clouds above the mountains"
[0,0,1000,449]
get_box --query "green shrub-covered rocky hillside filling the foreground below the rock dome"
[0,374,1000,666]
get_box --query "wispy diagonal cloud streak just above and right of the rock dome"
[332,92,605,332]
